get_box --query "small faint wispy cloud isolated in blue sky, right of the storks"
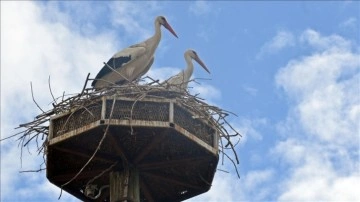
[256,30,295,59]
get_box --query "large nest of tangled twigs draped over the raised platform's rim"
[3,75,241,193]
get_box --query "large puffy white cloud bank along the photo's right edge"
[272,30,360,201]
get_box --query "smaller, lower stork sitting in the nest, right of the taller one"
[164,49,210,91]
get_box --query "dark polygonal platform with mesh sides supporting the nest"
[47,95,218,201]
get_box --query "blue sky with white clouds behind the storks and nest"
[1,1,360,201]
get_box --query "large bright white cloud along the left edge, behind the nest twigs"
[1,2,114,201]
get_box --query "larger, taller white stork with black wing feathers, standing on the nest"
[91,16,178,89]
